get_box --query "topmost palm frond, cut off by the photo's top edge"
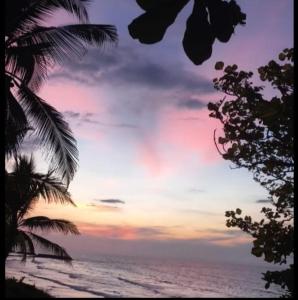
[5,0,88,36]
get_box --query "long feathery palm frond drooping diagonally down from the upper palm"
[18,85,78,185]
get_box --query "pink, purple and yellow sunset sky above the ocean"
[19,0,293,263]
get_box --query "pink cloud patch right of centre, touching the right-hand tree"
[138,108,222,176]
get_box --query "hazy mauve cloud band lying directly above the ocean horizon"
[46,232,262,266]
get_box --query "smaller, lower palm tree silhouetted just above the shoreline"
[5,156,79,261]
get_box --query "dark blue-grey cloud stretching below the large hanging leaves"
[50,46,214,92]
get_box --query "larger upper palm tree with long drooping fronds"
[4,0,117,184]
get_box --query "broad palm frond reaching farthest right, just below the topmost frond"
[5,24,117,91]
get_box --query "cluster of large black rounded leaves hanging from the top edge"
[128,0,246,65]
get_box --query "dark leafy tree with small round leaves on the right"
[208,49,294,296]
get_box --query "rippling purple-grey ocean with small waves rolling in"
[5,256,282,298]
